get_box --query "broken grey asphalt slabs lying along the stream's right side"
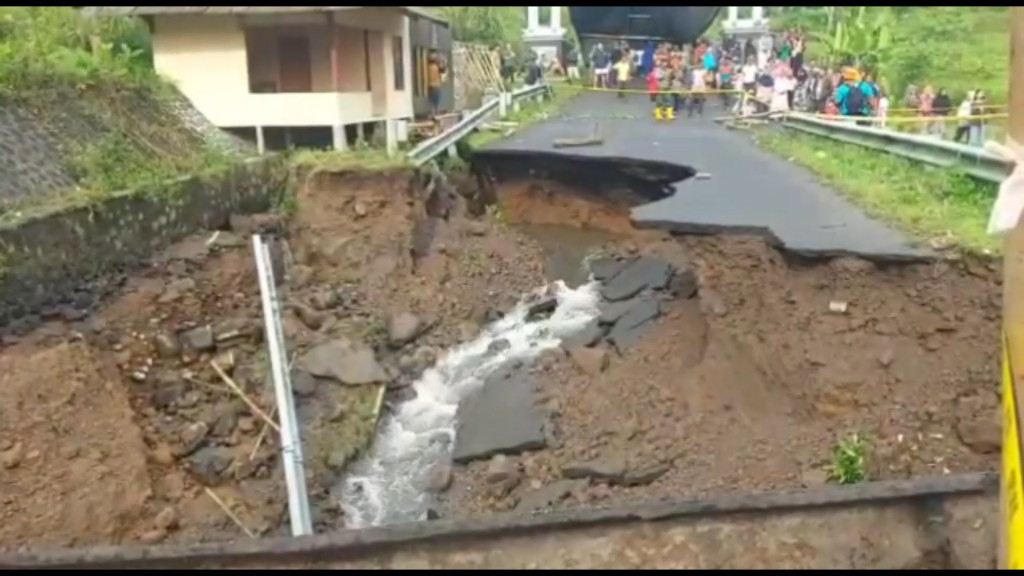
[444,256,697,511]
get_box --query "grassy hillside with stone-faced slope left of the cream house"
[0,6,249,219]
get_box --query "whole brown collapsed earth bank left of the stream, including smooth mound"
[0,166,544,549]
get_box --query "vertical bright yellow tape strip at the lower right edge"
[1001,337,1024,570]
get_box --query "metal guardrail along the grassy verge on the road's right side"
[782,113,1012,183]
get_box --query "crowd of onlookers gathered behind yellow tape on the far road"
[564,30,989,146]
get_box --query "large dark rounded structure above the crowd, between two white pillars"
[569,6,722,44]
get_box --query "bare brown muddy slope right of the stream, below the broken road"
[450,182,1000,516]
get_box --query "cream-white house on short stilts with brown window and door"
[87,6,444,149]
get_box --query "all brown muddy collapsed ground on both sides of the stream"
[0,163,1000,549]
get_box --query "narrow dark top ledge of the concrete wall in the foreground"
[0,472,998,570]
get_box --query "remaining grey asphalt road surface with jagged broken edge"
[486,92,935,260]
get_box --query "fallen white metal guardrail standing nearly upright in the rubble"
[253,235,313,536]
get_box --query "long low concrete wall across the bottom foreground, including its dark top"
[0,474,999,570]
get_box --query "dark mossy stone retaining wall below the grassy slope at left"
[0,157,288,332]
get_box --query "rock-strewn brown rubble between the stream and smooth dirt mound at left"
[0,167,557,543]
